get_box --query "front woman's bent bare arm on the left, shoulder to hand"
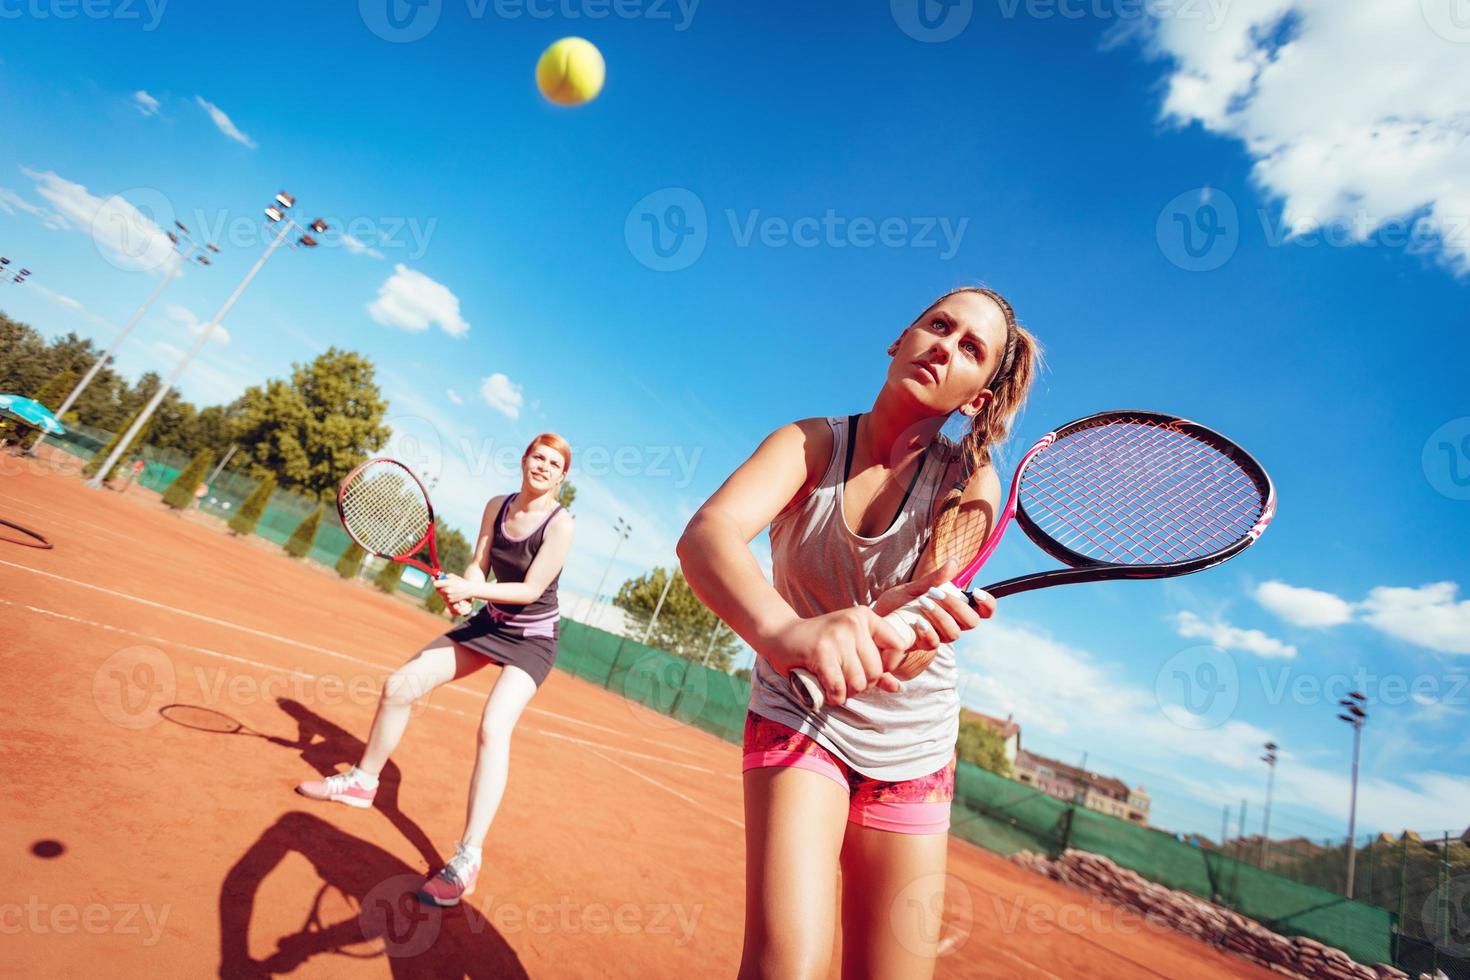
[679,419,904,704]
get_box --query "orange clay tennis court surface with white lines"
[0,455,1273,980]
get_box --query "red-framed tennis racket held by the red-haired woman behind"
[337,458,470,616]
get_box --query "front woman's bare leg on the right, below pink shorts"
[842,823,950,980]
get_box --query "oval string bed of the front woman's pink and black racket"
[1022,419,1264,564]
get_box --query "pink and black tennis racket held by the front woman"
[786,411,1276,711]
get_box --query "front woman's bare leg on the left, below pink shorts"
[739,765,848,980]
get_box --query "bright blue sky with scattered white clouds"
[0,0,1470,837]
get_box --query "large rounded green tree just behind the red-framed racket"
[234,347,390,497]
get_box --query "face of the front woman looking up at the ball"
[888,292,1005,414]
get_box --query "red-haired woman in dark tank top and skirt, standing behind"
[297,432,573,905]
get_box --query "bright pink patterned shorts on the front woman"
[741,711,954,833]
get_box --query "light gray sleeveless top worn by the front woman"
[750,417,960,782]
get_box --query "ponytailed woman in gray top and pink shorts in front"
[679,288,1039,980]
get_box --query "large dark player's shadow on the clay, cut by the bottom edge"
[219,811,528,980]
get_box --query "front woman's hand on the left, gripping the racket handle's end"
[761,605,907,704]
